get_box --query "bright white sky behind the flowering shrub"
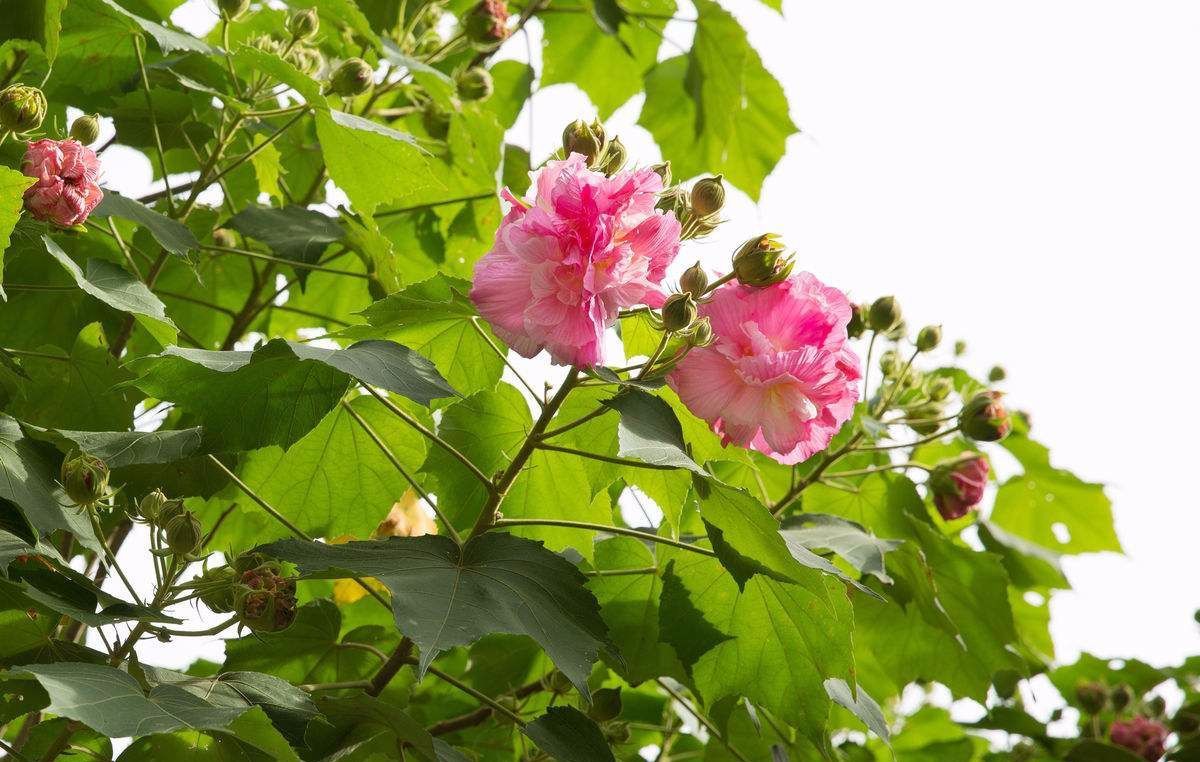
[88,0,1200,724]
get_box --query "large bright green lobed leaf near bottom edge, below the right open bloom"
[674,553,862,748]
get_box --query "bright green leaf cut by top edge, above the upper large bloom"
[540,0,676,119]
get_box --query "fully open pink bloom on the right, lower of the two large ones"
[667,272,860,464]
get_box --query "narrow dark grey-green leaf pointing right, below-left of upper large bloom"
[288,340,458,406]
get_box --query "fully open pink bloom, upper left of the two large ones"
[470,154,679,367]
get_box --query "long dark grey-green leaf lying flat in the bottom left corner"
[14,662,248,738]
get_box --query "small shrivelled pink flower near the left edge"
[20,139,104,228]
